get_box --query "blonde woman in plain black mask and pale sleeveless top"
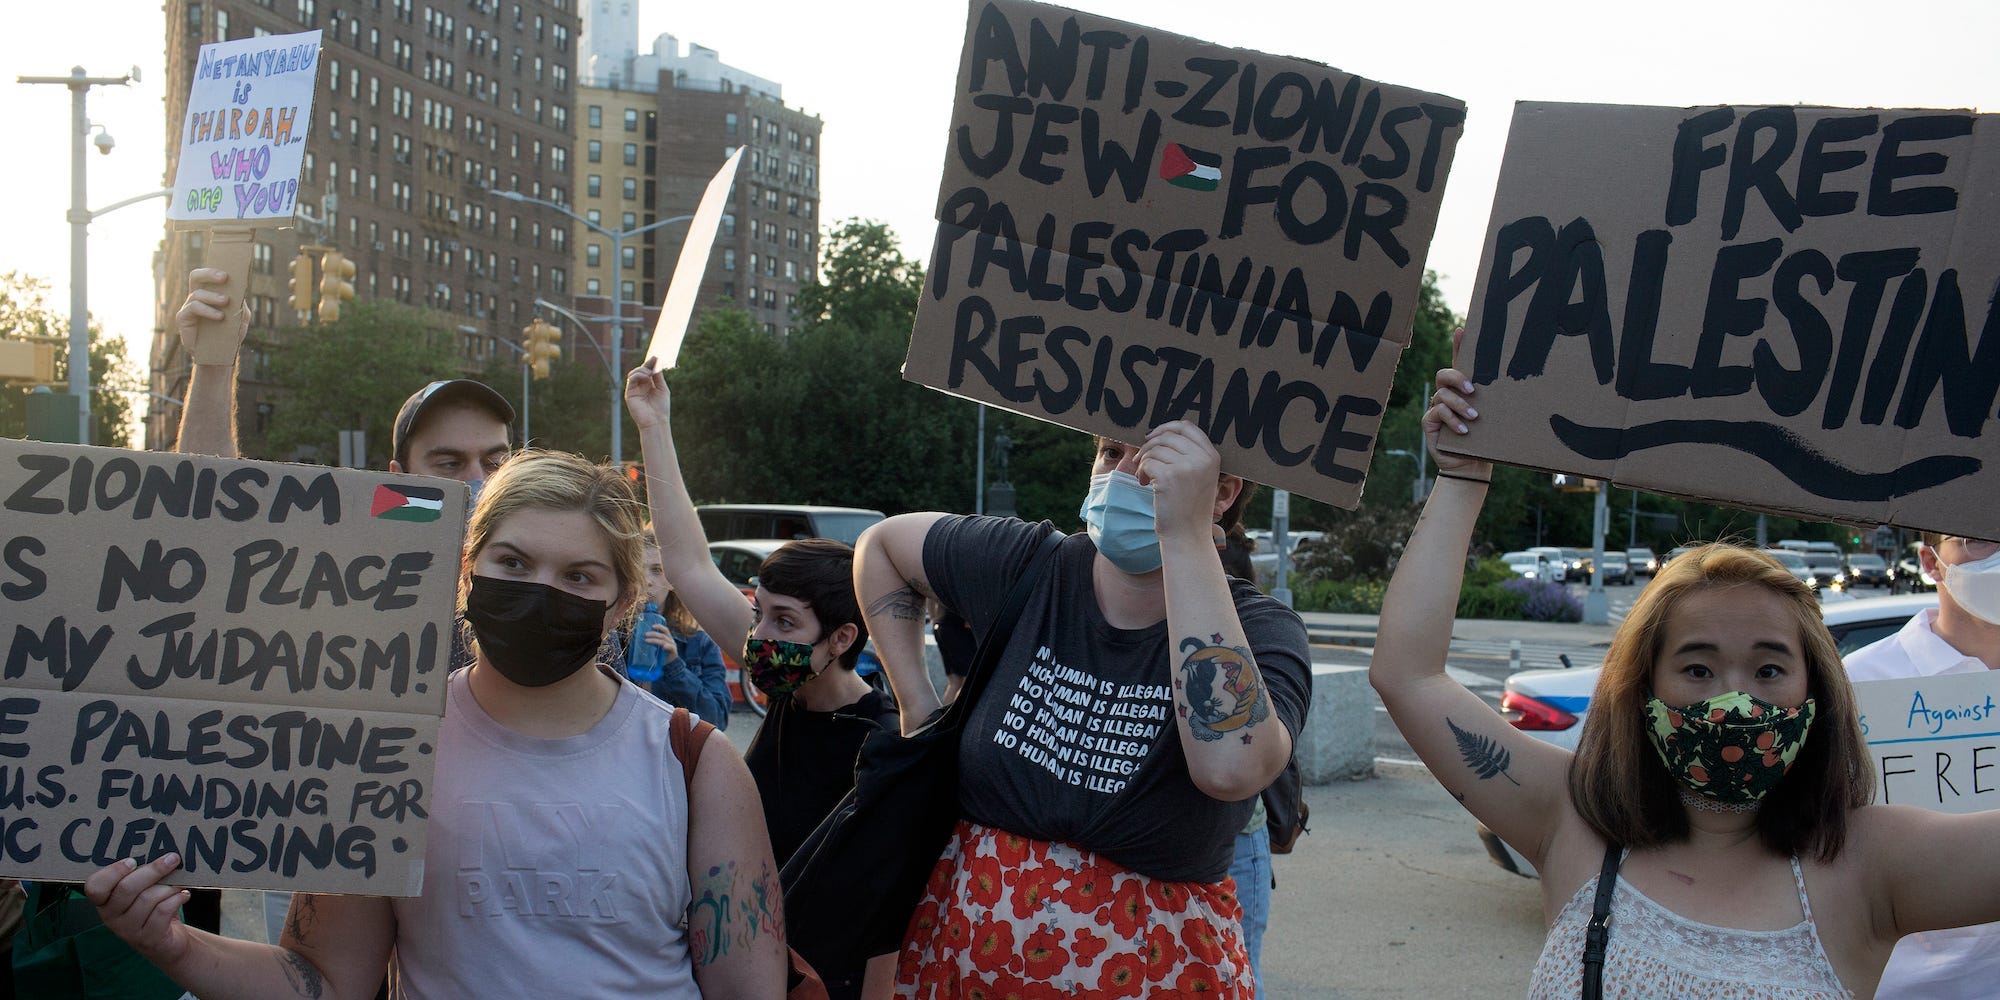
[84,452,786,1000]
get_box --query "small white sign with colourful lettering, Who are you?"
[166,32,320,224]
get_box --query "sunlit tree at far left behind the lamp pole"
[0,270,146,448]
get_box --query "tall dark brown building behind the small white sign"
[146,0,580,458]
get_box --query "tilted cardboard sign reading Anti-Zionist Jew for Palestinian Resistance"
[904,0,1466,508]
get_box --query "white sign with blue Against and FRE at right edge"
[1854,670,2000,812]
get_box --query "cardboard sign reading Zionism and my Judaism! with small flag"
[0,440,466,896]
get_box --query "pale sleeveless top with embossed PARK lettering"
[392,670,700,1000]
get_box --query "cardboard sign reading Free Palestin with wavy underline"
[1452,104,2000,538]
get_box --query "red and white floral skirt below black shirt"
[896,822,1256,1000]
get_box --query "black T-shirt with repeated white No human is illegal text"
[924,516,1312,882]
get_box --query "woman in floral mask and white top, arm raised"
[1370,356,2000,1000]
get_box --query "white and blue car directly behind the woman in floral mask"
[1480,592,1938,874]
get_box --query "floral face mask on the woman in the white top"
[1646,690,1814,802]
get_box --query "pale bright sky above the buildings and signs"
[0,0,2000,390]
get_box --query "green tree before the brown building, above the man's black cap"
[246,300,464,468]
